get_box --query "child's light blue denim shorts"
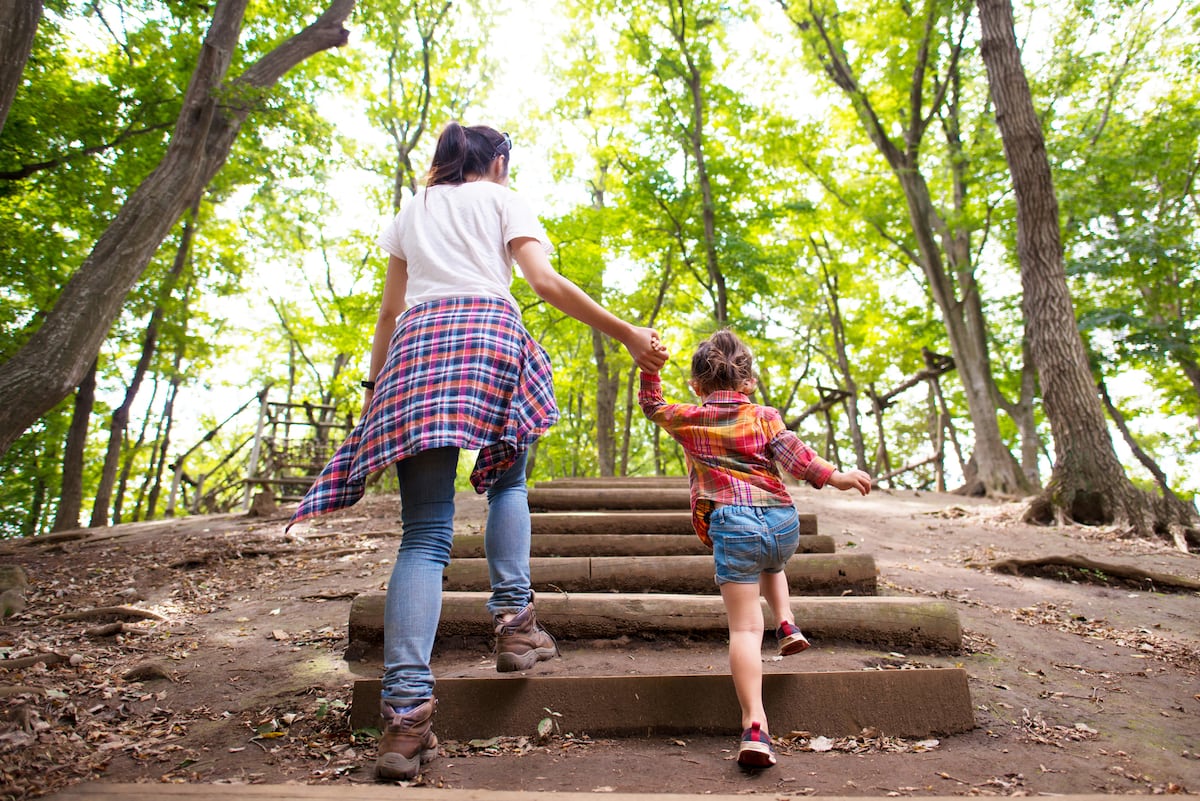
[708,506,800,585]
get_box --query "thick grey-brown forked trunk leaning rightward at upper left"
[0,0,354,453]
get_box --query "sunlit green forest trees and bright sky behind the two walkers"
[0,0,1200,548]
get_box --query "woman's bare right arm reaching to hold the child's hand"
[510,236,667,373]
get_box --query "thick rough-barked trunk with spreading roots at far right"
[977,0,1195,551]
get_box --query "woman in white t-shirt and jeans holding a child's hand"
[289,122,666,779]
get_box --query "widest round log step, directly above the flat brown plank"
[347,592,962,658]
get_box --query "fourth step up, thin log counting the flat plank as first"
[450,532,835,561]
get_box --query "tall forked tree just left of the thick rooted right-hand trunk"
[779,0,1030,494]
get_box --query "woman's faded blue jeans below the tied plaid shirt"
[383,447,533,706]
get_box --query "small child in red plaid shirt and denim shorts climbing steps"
[637,330,871,767]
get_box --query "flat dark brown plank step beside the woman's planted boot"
[350,668,974,741]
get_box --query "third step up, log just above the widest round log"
[442,556,876,596]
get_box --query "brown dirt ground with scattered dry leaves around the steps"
[0,489,1200,800]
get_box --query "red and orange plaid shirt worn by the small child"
[637,373,835,548]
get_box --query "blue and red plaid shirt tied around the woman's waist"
[288,297,558,526]
